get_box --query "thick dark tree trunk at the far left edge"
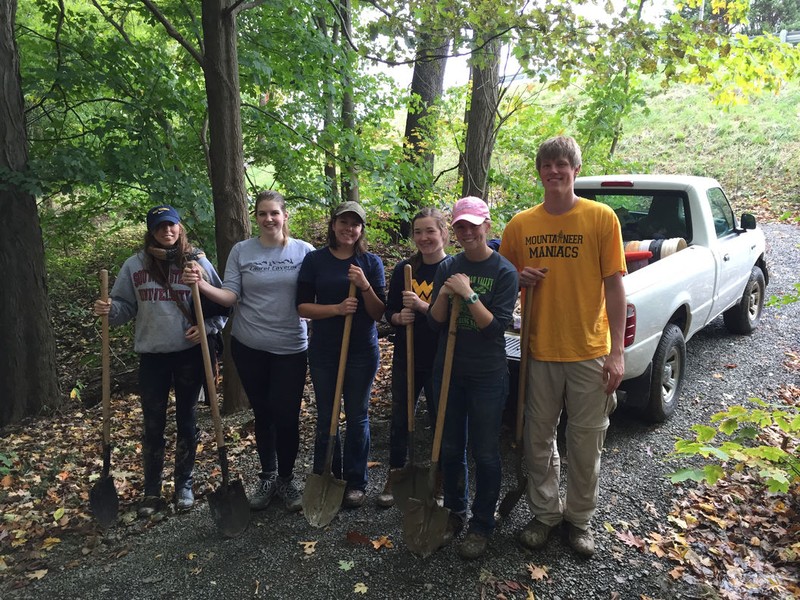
[0,0,63,427]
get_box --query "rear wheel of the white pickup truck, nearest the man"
[645,323,686,423]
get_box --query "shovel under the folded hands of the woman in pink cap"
[403,296,461,558]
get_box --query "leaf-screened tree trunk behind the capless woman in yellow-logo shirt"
[399,35,450,238]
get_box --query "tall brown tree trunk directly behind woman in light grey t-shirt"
[203,0,251,414]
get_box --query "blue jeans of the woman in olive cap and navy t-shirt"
[308,346,379,491]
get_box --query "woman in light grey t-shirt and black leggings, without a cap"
[184,190,314,511]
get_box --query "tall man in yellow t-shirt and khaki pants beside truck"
[500,136,626,556]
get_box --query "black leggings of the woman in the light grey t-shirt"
[231,337,307,477]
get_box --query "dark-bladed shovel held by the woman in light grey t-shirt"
[192,283,250,538]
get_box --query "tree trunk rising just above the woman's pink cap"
[461,39,500,199]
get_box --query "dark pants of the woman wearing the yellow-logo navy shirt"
[389,362,436,469]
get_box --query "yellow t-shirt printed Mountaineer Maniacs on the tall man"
[500,198,625,362]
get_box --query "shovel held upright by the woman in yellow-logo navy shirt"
[389,264,428,512]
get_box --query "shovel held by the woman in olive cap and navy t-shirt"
[303,282,356,527]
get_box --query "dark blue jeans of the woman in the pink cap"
[433,369,508,535]
